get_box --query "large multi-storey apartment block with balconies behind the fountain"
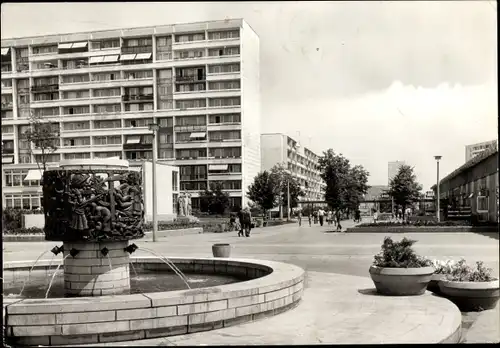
[1,19,260,209]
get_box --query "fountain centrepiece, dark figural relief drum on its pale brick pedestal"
[43,159,144,296]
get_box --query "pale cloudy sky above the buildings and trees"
[1,0,498,190]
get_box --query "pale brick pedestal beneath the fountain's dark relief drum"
[64,241,130,296]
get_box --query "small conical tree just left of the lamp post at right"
[387,165,422,209]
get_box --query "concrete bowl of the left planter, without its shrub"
[370,266,434,296]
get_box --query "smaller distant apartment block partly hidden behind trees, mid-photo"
[260,133,326,201]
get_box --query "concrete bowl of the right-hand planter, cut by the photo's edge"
[439,279,500,312]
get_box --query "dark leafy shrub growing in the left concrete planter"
[373,237,432,268]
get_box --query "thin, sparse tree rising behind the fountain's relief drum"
[24,112,60,171]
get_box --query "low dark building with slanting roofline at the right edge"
[432,145,499,222]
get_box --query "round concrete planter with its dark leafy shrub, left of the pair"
[370,237,434,296]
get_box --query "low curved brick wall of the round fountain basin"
[4,257,304,345]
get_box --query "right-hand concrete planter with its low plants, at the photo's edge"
[439,259,500,312]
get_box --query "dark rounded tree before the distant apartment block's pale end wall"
[247,170,279,216]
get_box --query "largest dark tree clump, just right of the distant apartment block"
[319,149,370,211]
